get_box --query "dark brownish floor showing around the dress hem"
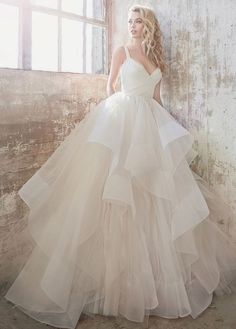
[0,294,236,329]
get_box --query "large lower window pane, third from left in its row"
[62,18,83,72]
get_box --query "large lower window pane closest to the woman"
[86,24,107,74]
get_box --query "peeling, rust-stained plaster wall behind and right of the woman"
[113,0,236,236]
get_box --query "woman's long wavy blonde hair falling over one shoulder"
[128,5,168,72]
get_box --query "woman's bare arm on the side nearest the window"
[106,47,125,96]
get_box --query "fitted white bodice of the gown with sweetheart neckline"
[120,47,162,98]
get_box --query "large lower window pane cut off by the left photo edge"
[0,4,19,68]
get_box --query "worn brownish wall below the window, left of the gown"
[0,69,107,282]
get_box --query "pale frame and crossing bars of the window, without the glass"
[0,0,112,74]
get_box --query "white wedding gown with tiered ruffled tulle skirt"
[5,47,236,329]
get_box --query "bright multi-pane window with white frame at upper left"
[0,0,111,74]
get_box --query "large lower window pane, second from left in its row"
[32,11,58,71]
